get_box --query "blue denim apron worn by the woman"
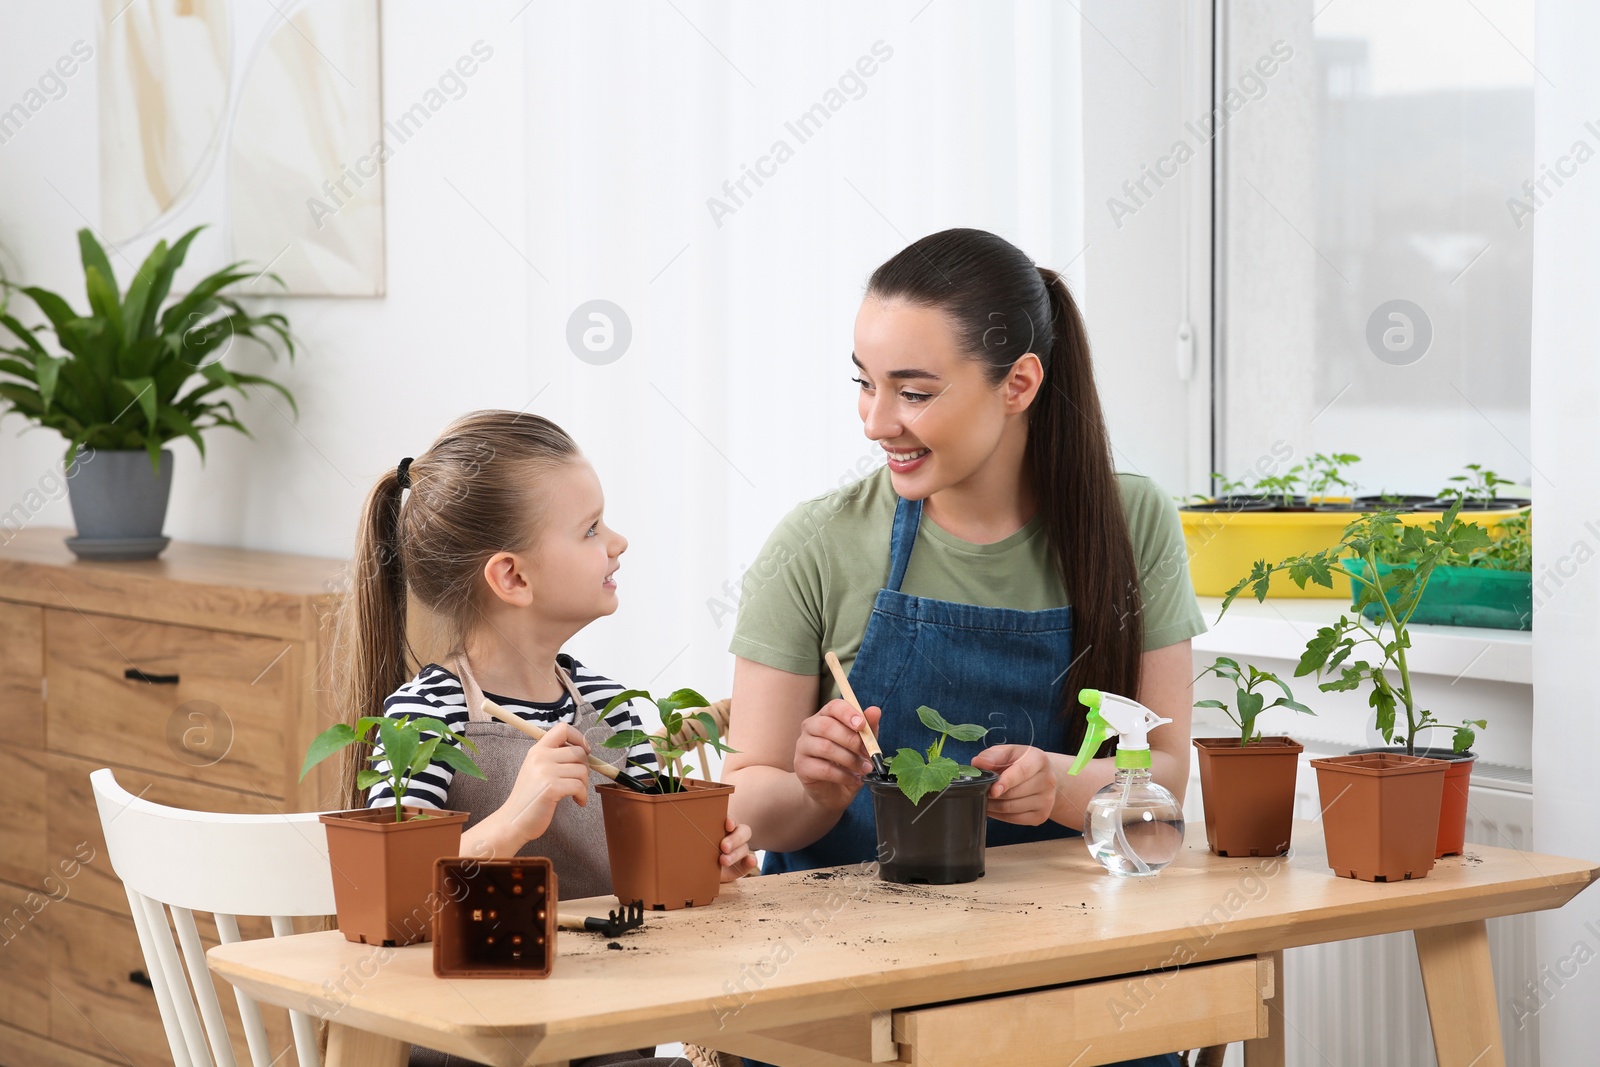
[746,498,1182,1067]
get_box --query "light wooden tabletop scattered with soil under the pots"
[210,824,1597,1067]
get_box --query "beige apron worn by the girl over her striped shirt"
[445,654,627,901]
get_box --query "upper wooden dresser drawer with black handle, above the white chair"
[45,609,302,798]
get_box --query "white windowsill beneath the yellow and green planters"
[1194,597,1533,685]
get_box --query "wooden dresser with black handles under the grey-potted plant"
[0,530,346,1067]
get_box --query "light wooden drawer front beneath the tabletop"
[891,958,1275,1067]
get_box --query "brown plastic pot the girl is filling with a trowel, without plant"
[597,779,733,912]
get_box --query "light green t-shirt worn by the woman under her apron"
[731,467,1205,699]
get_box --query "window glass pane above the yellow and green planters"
[1214,0,1536,493]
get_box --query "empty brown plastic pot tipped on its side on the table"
[434,856,557,977]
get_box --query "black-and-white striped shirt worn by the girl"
[366,653,656,809]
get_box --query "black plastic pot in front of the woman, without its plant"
[867,771,998,886]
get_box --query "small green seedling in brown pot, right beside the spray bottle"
[1194,656,1315,856]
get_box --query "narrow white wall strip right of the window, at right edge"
[1523,0,1600,1064]
